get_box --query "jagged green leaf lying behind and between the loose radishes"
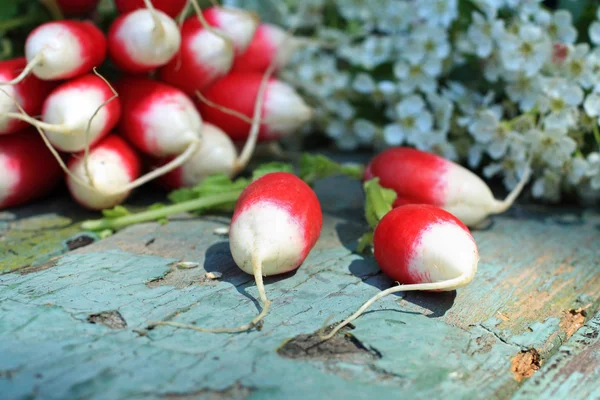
[300,153,364,184]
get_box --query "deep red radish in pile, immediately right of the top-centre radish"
[158,16,234,96]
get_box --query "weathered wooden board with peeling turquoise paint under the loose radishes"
[0,178,600,399]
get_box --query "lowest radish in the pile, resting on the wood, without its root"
[67,134,141,210]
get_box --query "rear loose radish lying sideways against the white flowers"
[364,147,531,227]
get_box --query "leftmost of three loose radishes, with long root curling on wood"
[154,172,323,333]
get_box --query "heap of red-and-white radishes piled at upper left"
[0,0,312,210]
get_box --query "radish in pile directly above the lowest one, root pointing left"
[3,74,121,153]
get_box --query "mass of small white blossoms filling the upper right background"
[225,0,600,201]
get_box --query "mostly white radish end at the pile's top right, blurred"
[202,7,258,54]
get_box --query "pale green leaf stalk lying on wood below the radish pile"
[81,189,242,231]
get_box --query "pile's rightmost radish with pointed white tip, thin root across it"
[197,73,312,141]
